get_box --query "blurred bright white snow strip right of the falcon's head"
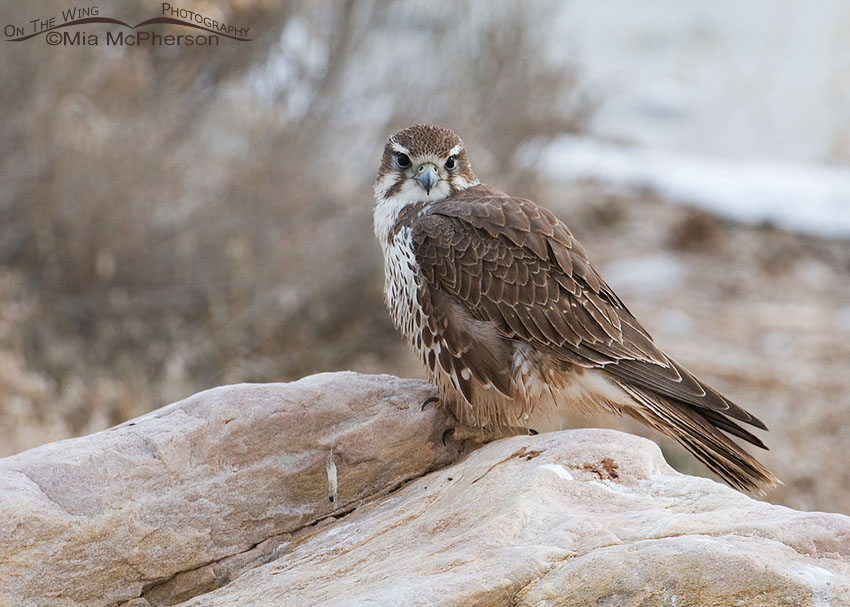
[521,136,850,238]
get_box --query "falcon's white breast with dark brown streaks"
[384,226,423,340]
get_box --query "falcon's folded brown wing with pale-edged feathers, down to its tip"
[412,186,765,436]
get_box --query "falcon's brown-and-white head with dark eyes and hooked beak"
[375,124,478,205]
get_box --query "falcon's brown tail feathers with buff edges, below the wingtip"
[620,384,782,495]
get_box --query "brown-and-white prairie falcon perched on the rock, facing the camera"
[374,125,778,490]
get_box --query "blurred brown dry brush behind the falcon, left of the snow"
[0,0,585,444]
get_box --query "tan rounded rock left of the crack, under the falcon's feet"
[0,373,459,607]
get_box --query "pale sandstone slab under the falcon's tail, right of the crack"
[172,430,850,607]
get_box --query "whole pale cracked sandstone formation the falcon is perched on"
[0,373,850,607]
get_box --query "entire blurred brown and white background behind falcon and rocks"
[0,0,850,513]
